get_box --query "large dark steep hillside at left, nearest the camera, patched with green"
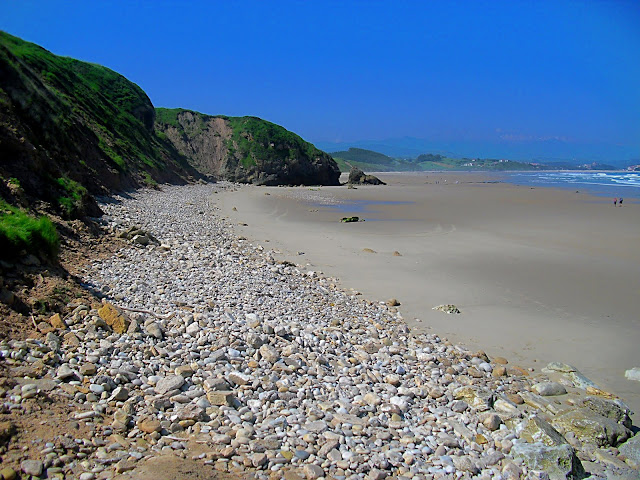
[0,32,197,217]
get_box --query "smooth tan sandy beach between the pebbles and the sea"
[218,173,640,412]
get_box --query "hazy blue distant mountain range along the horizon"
[316,137,640,168]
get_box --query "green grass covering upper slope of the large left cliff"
[0,32,166,178]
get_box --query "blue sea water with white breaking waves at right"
[504,171,640,199]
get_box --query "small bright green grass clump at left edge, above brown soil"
[0,200,60,260]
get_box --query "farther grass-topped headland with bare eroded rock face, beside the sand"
[156,108,340,185]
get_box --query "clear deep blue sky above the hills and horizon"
[0,0,640,161]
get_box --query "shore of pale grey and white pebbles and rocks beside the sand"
[0,184,640,480]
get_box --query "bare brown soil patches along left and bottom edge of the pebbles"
[0,219,242,480]
